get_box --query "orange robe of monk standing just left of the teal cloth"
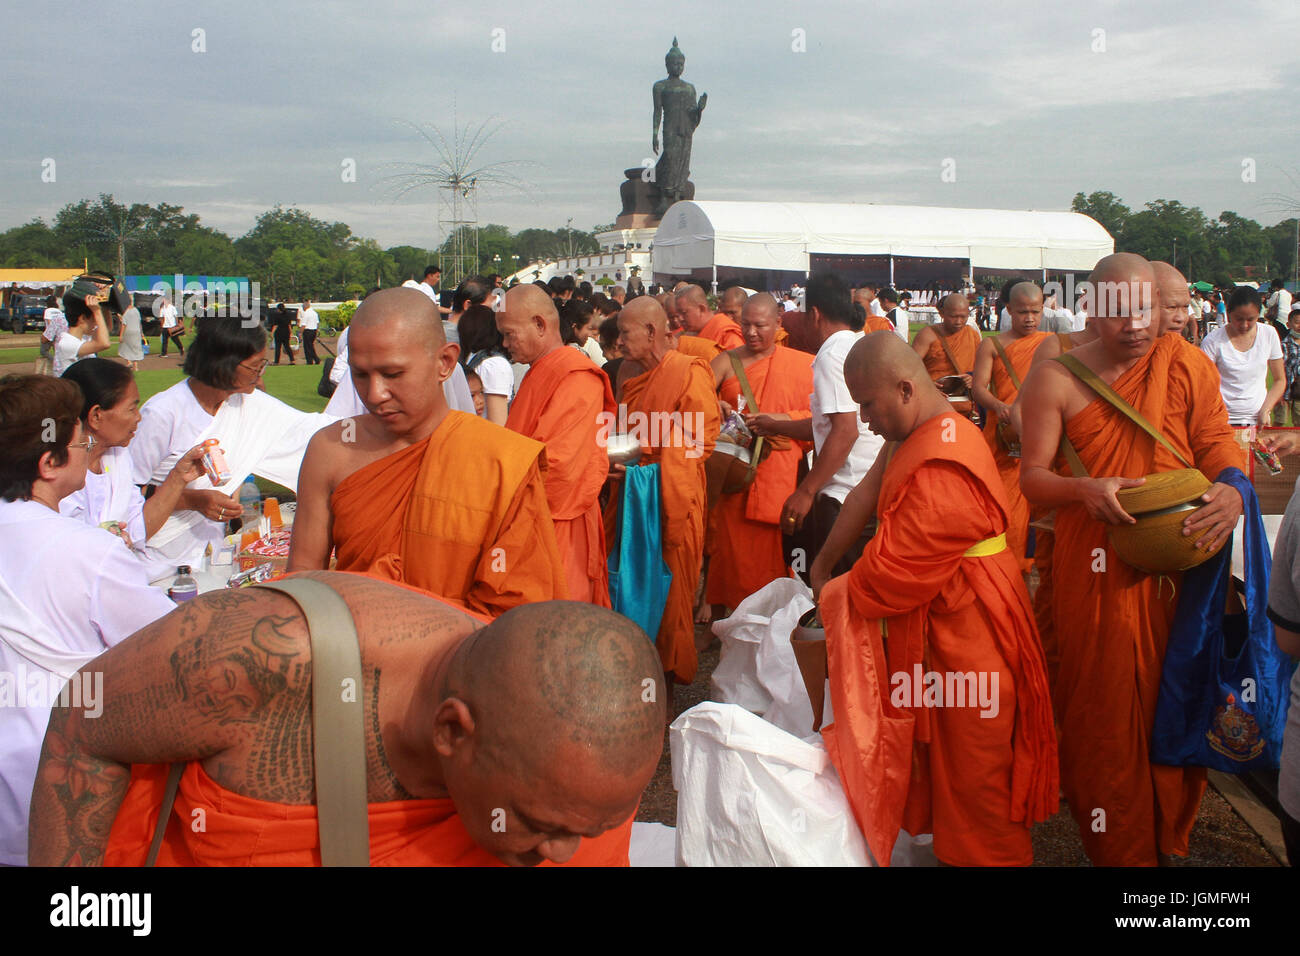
[506,349,618,607]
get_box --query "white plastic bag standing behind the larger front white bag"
[712,578,814,737]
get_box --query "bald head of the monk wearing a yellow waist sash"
[844,330,961,441]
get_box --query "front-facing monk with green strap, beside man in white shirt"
[706,293,813,609]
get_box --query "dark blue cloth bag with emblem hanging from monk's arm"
[1159,468,1291,774]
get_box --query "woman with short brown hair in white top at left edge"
[0,375,174,866]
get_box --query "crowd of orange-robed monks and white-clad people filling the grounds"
[0,254,1300,865]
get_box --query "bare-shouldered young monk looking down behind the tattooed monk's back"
[289,289,568,617]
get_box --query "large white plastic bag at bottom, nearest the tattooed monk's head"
[670,698,871,866]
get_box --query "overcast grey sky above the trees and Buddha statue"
[0,0,1300,246]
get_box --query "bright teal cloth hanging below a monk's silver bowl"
[610,464,672,641]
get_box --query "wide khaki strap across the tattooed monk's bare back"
[259,578,371,866]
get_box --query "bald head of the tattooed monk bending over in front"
[433,601,670,864]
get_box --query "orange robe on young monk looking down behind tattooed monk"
[330,411,568,617]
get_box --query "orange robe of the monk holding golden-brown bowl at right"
[1052,336,1245,866]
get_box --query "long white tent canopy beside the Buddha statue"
[653,202,1114,274]
